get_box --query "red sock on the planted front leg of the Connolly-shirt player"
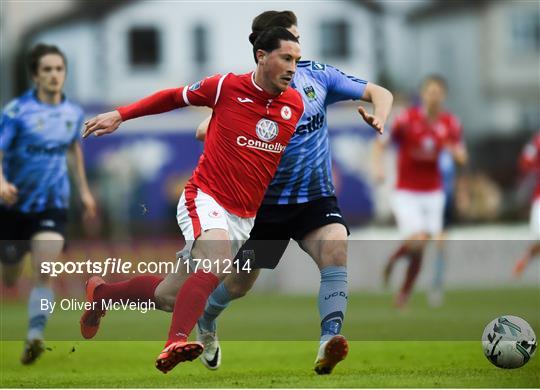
[165,271,219,346]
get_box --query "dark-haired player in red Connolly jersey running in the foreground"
[81,27,304,373]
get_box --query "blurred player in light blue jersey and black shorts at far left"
[0,44,96,364]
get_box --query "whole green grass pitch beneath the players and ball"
[0,289,540,388]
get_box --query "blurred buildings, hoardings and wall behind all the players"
[0,0,540,330]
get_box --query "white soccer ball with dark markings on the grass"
[482,315,537,368]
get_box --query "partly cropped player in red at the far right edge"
[514,134,540,277]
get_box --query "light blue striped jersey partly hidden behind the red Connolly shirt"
[263,61,367,204]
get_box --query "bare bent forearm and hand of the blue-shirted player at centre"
[358,83,394,134]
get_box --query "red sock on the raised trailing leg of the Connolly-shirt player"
[94,275,163,302]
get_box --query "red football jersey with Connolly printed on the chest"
[181,72,304,218]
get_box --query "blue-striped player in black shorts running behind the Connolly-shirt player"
[190,11,393,374]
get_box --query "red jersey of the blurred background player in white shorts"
[391,107,461,191]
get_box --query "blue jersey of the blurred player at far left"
[0,90,83,213]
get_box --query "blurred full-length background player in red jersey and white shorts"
[375,75,467,307]
